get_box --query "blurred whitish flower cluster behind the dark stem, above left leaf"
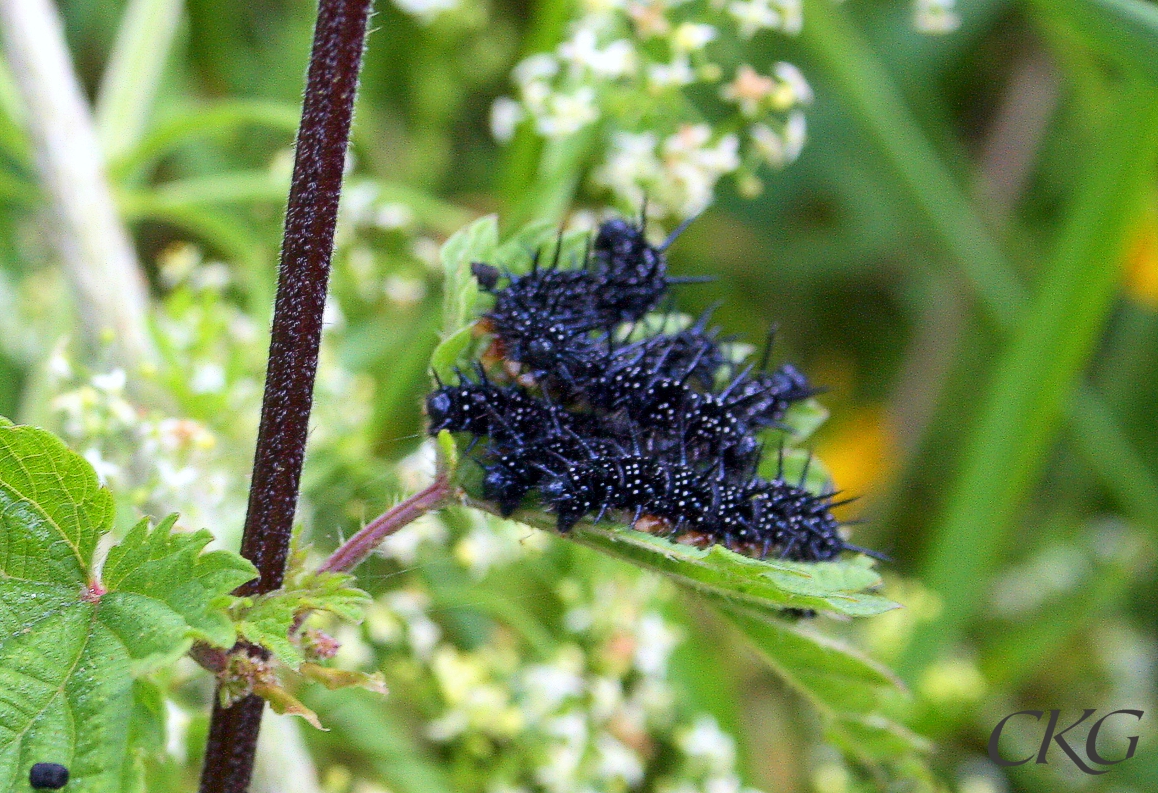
[38,240,384,555]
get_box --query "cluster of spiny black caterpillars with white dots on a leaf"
[426,220,860,561]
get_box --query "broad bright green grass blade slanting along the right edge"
[901,83,1158,676]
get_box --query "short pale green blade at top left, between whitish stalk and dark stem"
[95,0,185,160]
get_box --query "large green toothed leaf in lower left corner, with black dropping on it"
[0,420,256,793]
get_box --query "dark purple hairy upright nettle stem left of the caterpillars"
[200,0,371,793]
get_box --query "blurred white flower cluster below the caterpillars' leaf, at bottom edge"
[356,537,755,793]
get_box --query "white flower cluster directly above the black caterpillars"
[491,0,812,218]
